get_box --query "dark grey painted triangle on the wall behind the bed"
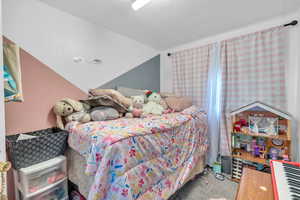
[99,55,160,92]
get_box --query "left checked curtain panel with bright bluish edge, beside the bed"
[172,44,221,164]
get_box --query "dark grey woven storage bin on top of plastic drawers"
[6,128,68,169]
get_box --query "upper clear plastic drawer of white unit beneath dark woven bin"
[15,156,67,196]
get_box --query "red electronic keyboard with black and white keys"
[271,160,300,200]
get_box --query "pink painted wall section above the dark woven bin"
[5,40,87,135]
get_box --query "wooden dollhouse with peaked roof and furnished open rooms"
[230,102,292,181]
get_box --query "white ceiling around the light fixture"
[40,0,300,50]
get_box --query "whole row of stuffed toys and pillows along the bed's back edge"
[53,89,190,129]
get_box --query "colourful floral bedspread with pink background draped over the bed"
[67,107,208,200]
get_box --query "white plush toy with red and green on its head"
[143,92,164,115]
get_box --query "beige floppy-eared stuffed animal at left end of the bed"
[53,98,90,129]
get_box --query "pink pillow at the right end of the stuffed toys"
[165,96,193,112]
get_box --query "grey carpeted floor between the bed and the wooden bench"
[169,172,238,200]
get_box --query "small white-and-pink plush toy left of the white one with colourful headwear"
[125,95,145,118]
